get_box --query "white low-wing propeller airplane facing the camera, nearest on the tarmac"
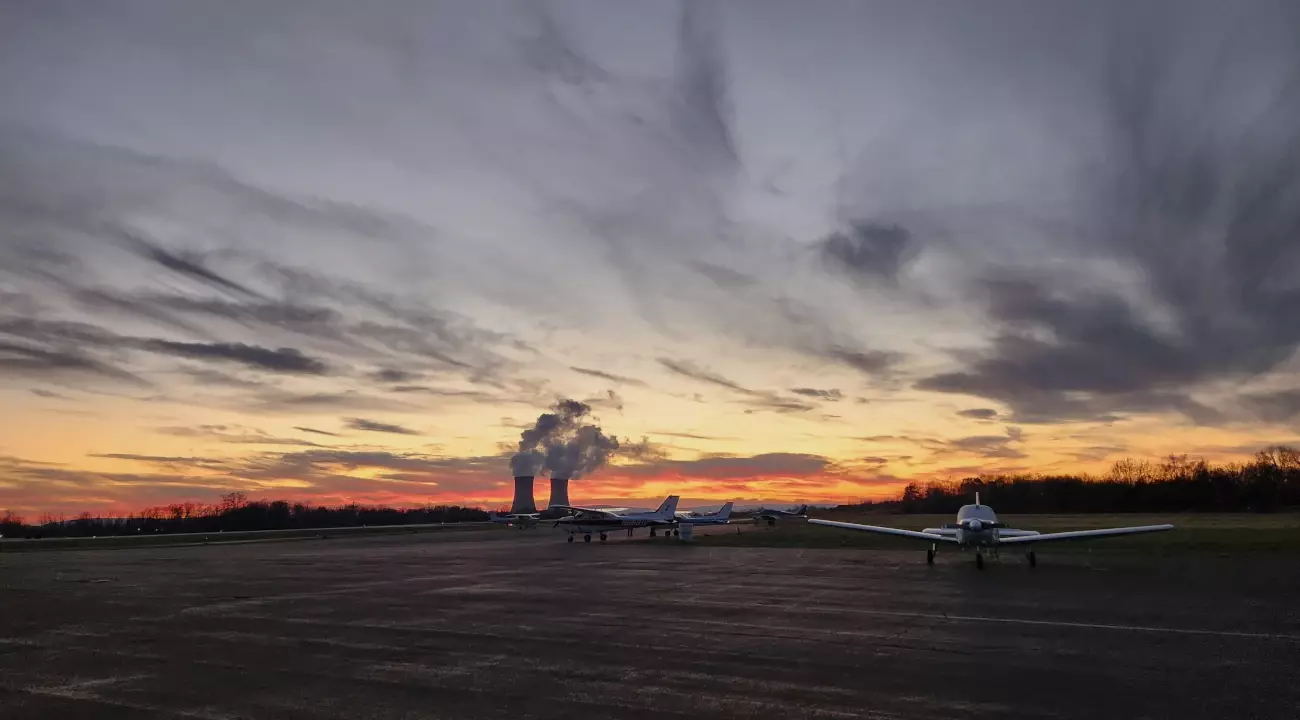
[809,493,1174,569]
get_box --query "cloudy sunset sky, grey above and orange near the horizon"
[0,0,1300,515]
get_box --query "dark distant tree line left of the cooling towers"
[0,493,488,538]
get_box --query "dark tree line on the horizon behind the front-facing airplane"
[859,446,1300,515]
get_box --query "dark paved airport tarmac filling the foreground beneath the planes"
[0,529,1300,720]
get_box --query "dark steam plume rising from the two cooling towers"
[510,399,619,480]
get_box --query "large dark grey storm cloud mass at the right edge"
[918,6,1300,422]
